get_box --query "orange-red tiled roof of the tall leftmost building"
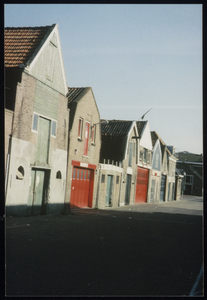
[4,24,55,67]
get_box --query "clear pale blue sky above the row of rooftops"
[5,4,203,154]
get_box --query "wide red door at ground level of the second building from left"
[70,167,93,208]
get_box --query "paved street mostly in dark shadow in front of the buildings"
[5,196,203,296]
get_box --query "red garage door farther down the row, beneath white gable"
[135,168,148,203]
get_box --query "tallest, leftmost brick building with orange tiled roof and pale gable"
[4,24,69,215]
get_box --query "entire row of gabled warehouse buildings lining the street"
[4,24,183,216]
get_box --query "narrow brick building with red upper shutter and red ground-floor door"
[65,87,101,212]
